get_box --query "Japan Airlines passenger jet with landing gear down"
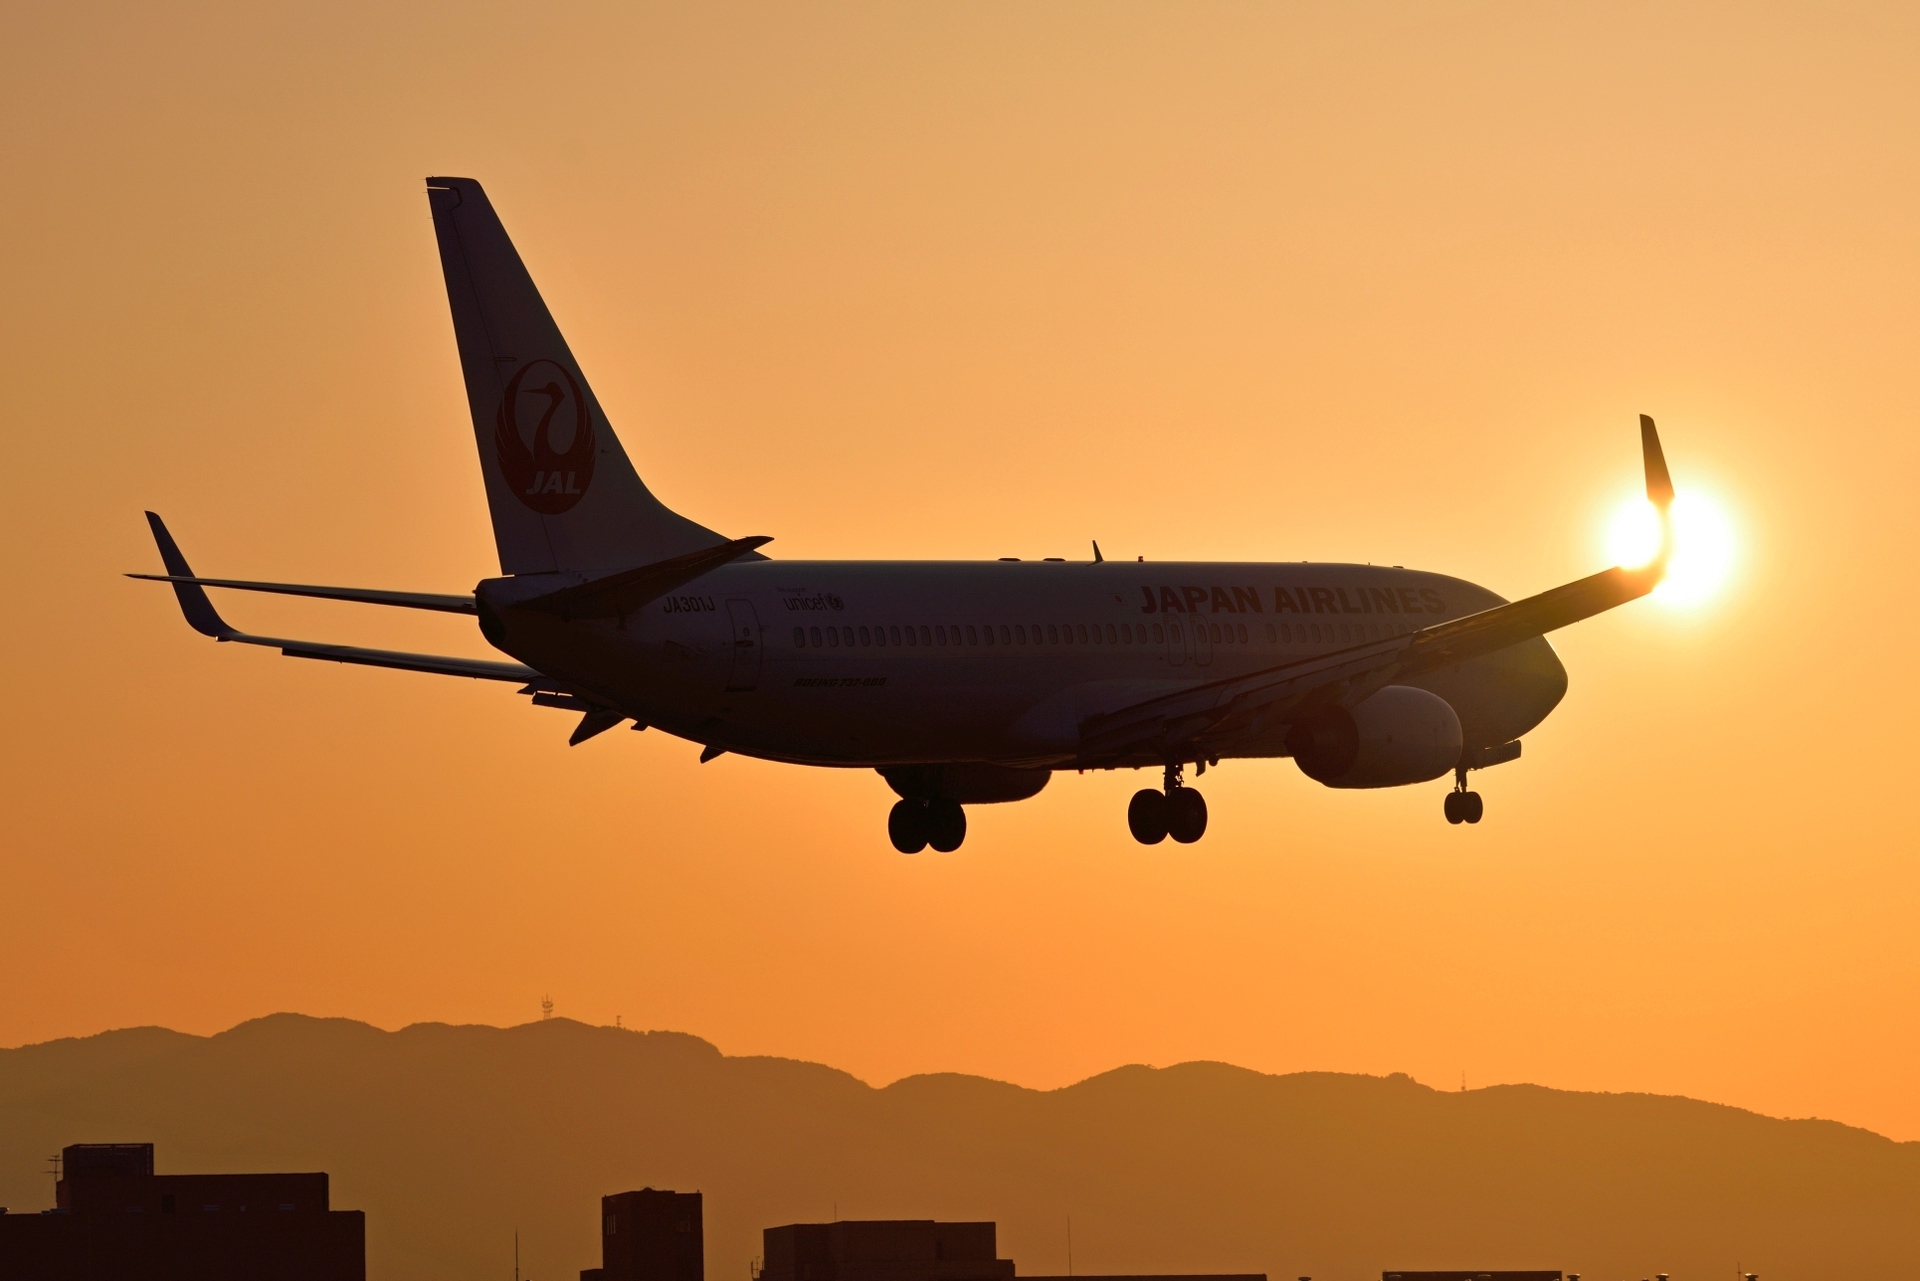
[129,179,1674,855]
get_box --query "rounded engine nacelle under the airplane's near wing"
[1286,686,1461,787]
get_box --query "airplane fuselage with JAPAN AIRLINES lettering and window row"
[478,561,1567,768]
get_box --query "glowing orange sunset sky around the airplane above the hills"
[0,0,1920,1139]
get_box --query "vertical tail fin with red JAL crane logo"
[426,179,741,574]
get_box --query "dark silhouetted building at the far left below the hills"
[0,1143,367,1281]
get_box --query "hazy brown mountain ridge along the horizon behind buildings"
[0,1014,1920,1281]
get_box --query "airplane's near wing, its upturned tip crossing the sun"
[1081,415,1674,759]
